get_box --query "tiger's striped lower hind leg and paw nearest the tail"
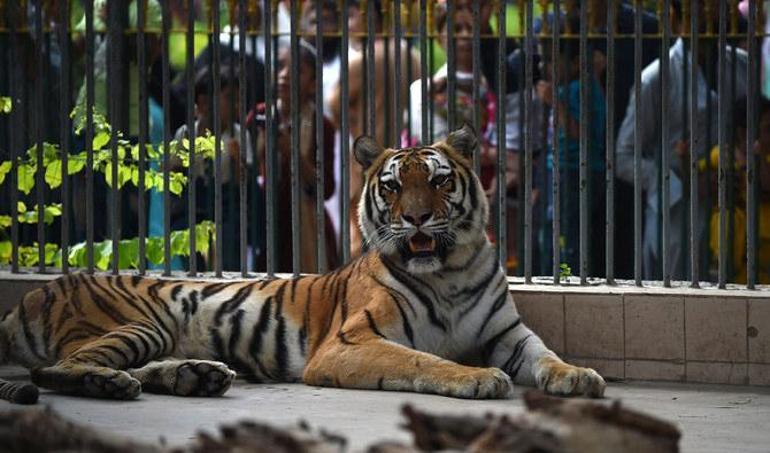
[31,323,173,400]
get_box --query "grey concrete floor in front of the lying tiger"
[0,367,770,452]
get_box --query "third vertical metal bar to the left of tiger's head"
[290,0,301,277]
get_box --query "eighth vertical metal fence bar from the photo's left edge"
[185,0,196,277]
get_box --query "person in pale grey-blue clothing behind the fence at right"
[615,0,747,279]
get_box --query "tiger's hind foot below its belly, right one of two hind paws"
[127,359,235,396]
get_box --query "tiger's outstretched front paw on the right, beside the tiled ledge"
[535,357,607,398]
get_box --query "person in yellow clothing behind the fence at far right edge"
[698,97,770,284]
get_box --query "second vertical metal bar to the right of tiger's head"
[520,0,535,283]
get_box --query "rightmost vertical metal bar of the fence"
[746,2,758,289]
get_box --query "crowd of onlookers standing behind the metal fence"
[1,0,770,282]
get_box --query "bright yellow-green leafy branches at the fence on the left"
[0,102,224,270]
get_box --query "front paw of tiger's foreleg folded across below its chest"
[416,368,513,399]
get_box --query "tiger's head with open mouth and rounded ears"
[353,125,489,273]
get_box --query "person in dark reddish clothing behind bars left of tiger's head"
[250,40,337,273]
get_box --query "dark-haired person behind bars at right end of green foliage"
[171,65,254,271]
